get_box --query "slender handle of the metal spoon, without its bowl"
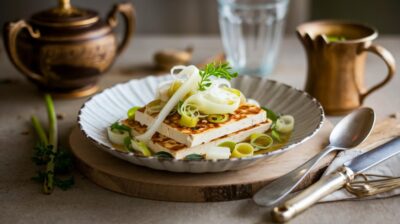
[253,146,340,206]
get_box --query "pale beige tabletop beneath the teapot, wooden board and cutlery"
[0,36,400,224]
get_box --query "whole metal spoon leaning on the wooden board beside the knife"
[253,107,375,206]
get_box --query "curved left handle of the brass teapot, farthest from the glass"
[4,20,44,82]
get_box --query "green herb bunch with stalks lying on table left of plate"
[32,94,74,194]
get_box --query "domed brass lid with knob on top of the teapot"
[31,0,99,27]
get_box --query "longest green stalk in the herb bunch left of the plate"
[43,94,58,194]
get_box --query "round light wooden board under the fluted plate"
[69,121,335,202]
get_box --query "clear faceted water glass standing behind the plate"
[218,0,289,76]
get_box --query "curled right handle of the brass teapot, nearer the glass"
[107,2,136,54]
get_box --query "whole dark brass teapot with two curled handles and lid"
[3,0,135,97]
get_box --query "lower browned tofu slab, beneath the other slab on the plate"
[122,119,272,159]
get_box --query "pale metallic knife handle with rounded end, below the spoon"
[272,167,354,222]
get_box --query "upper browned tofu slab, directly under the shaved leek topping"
[135,104,267,147]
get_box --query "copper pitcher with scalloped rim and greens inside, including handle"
[297,21,396,115]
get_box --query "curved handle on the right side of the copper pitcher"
[359,44,396,104]
